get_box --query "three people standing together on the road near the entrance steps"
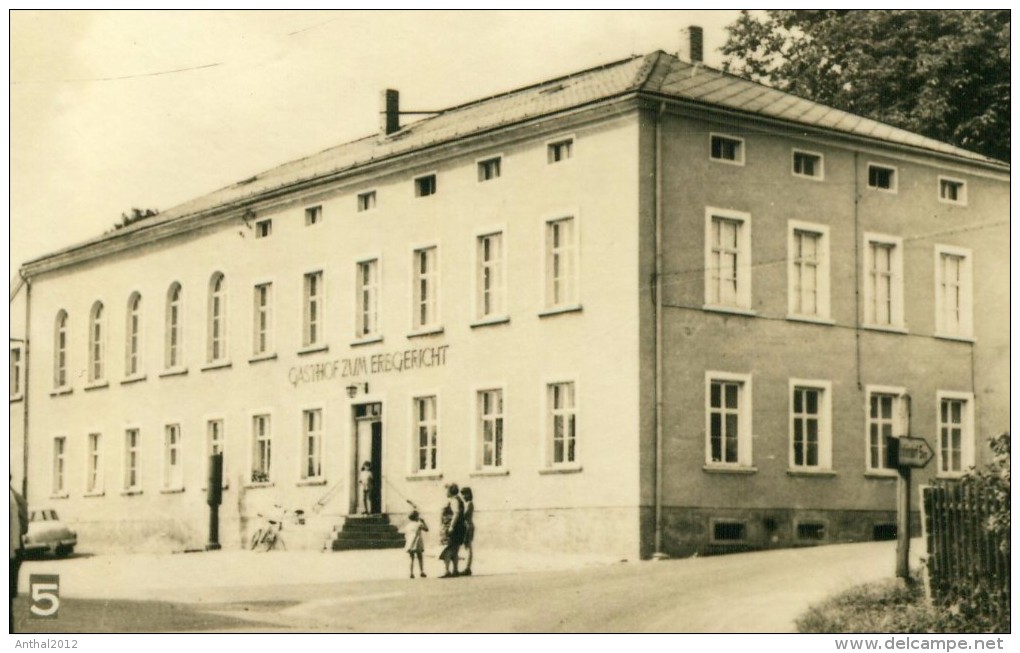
[404,484,474,579]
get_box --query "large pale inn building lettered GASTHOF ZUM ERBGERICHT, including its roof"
[11,52,1009,557]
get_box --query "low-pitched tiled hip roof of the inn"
[27,51,1008,267]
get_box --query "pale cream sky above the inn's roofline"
[9,9,738,283]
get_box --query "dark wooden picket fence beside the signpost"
[921,483,1010,619]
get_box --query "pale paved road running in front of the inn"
[11,543,919,633]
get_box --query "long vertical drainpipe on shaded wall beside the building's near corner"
[652,102,668,560]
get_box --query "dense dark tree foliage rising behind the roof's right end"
[722,9,1010,161]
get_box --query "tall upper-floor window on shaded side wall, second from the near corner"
[787,220,829,319]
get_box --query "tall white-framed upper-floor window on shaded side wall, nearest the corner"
[705,208,751,310]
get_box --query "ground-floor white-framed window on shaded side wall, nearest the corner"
[705,371,752,466]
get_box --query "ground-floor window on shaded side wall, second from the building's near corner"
[789,380,832,471]
